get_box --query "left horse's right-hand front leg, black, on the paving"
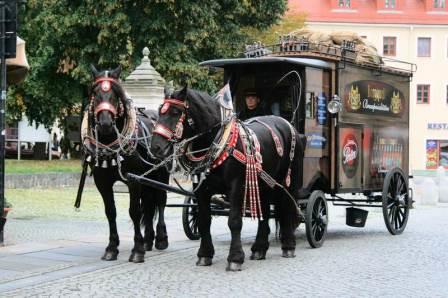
[128,183,145,263]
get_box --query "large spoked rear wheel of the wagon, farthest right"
[383,168,410,235]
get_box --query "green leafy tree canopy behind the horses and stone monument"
[8,0,287,126]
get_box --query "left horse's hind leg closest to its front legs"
[142,186,156,251]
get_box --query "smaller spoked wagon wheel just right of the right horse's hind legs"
[305,190,328,248]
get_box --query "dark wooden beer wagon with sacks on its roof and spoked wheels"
[128,32,416,247]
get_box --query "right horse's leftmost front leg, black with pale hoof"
[195,184,215,266]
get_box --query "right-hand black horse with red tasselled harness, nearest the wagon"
[151,87,305,271]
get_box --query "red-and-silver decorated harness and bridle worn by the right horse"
[154,99,296,219]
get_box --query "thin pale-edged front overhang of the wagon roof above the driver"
[199,57,335,69]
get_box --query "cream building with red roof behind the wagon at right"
[288,0,448,173]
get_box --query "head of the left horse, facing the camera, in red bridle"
[89,65,126,136]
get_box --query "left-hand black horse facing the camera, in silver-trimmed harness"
[81,66,169,263]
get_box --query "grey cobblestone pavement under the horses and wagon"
[0,201,448,297]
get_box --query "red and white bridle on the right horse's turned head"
[153,98,190,143]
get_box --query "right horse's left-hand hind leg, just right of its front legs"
[250,196,271,260]
